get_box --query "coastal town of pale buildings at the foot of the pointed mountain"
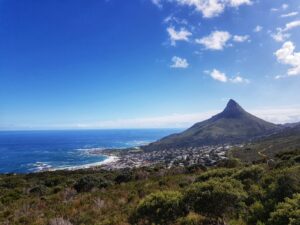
[90,145,236,170]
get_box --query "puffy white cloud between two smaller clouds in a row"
[195,31,231,50]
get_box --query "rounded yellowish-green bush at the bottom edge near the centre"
[129,191,187,225]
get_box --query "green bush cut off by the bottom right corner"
[269,194,300,225]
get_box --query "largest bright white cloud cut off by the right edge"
[274,41,300,79]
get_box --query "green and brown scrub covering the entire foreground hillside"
[0,150,300,225]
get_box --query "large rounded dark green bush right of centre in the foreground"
[184,178,246,221]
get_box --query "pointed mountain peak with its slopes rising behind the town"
[144,99,279,150]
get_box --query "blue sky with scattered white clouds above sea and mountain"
[0,0,300,130]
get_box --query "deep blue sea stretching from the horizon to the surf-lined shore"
[0,129,179,173]
